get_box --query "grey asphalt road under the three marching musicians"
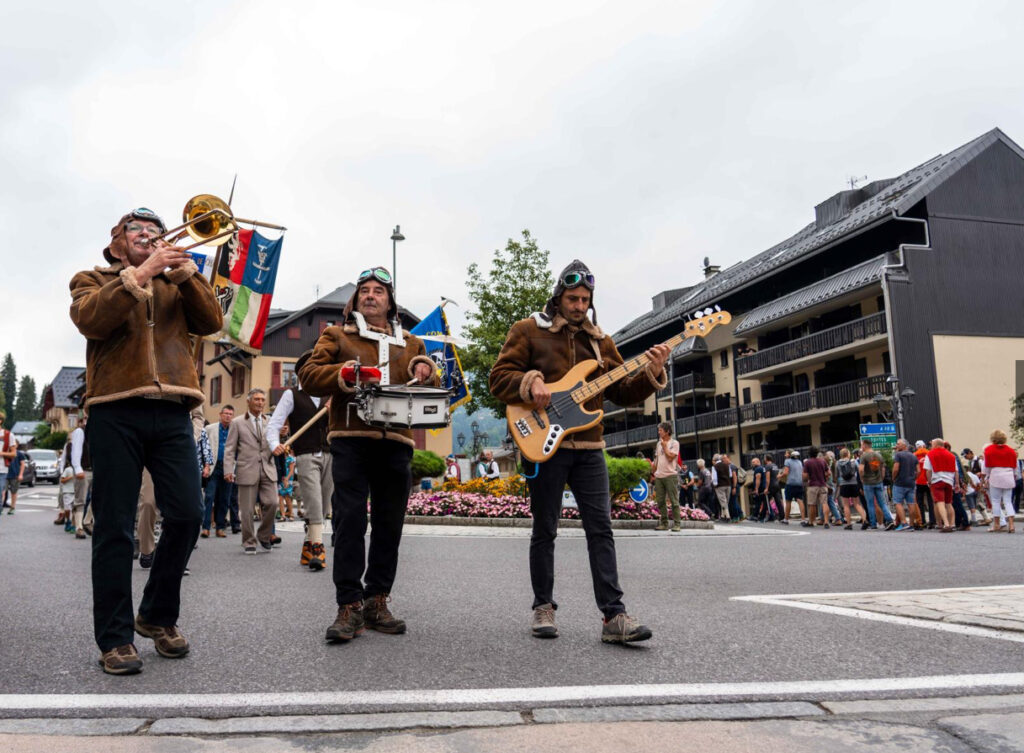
[0,486,1024,694]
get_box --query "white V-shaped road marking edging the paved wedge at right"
[730,586,1024,643]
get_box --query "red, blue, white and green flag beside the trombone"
[213,231,284,354]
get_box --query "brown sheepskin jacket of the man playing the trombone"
[71,262,221,409]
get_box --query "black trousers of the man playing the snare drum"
[331,436,413,606]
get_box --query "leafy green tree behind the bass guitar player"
[460,231,554,417]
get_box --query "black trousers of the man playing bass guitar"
[526,450,626,620]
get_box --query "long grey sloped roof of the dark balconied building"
[612,128,1024,345]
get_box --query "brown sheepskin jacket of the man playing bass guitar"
[489,315,668,450]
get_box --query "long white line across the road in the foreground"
[0,672,1024,713]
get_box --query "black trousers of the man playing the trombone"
[86,398,203,652]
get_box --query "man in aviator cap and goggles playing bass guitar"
[489,260,670,643]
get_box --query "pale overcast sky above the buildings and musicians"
[0,0,1024,397]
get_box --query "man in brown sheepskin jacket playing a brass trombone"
[71,209,221,674]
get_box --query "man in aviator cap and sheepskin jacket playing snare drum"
[295,266,438,642]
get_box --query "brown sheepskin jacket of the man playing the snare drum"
[299,322,439,447]
